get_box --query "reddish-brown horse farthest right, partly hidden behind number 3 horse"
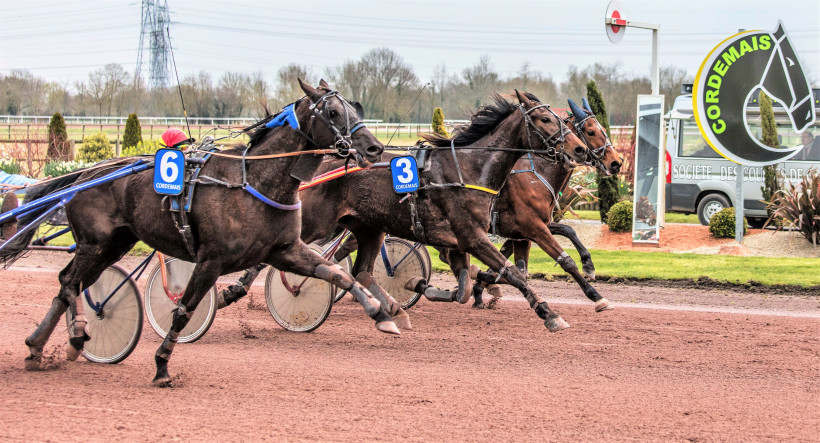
[473,99,623,312]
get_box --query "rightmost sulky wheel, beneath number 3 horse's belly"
[373,237,429,309]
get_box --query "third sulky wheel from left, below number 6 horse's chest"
[265,244,335,332]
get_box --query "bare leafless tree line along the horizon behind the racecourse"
[0,48,692,125]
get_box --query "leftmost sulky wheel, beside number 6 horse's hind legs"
[66,266,142,363]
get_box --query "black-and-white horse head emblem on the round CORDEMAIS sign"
[760,23,815,132]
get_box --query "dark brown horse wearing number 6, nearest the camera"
[10,79,399,387]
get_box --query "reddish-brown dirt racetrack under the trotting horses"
[0,259,820,441]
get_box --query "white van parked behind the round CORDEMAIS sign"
[665,85,820,227]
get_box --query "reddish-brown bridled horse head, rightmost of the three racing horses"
[567,98,623,176]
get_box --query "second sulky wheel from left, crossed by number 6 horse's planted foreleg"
[144,258,217,343]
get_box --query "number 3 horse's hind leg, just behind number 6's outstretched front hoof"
[350,229,413,330]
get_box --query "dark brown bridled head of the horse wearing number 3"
[515,90,587,166]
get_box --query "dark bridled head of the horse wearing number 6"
[297,79,384,168]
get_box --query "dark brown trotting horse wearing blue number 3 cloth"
[302,91,587,332]
